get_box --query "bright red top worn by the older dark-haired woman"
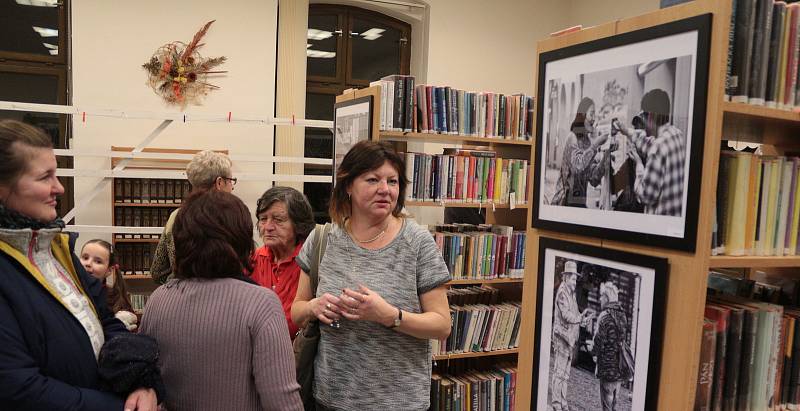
[252,242,303,339]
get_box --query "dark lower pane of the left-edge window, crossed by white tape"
[0,71,66,147]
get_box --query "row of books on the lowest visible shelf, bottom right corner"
[695,269,800,410]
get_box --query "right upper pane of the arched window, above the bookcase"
[350,17,402,81]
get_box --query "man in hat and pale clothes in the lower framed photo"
[550,261,594,411]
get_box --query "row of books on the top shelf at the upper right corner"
[725,0,800,109]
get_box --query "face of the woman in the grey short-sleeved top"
[348,161,400,222]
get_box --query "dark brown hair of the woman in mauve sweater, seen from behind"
[172,190,254,278]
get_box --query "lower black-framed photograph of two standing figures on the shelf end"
[531,237,668,411]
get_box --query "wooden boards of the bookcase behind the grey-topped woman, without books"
[336,86,534,409]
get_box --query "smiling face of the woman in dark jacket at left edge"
[0,146,64,223]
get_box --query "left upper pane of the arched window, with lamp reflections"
[306,14,339,77]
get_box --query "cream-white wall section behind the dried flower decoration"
[72,0,278,245]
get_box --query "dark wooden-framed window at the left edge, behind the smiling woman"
[0,0,73,216]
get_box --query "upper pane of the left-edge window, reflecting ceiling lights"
[0,0,60,56]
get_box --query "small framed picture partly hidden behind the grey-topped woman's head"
[333,96,373,184]
